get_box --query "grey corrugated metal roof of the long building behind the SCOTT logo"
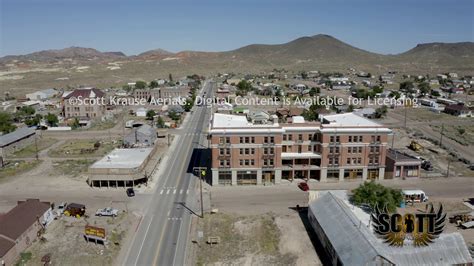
[309,192,472,265]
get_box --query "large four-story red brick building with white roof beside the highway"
[209,113,391,185]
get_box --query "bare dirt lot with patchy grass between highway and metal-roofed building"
[197,212,321,265]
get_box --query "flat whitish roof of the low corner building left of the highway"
[90,148,153,169]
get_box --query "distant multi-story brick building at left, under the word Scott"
[63,88,107,119]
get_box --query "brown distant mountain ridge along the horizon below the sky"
[0,34,474,71]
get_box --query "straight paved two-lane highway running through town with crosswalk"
[123,81,215,266]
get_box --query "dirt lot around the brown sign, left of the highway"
[25,209,132,265]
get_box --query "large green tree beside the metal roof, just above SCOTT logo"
[351,181,403,212]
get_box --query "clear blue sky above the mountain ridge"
[0,0,474,56]
